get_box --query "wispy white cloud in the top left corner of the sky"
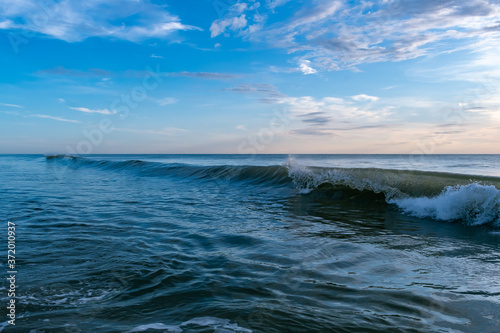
[0,0,201,42]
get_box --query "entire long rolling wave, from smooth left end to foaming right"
[46,155,500,227]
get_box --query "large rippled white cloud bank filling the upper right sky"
[211,0,500,74]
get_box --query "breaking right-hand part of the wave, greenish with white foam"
[286,160,500,227]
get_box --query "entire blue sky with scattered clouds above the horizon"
[0,0,500,154]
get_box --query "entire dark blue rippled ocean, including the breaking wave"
[0,155,500,333]
